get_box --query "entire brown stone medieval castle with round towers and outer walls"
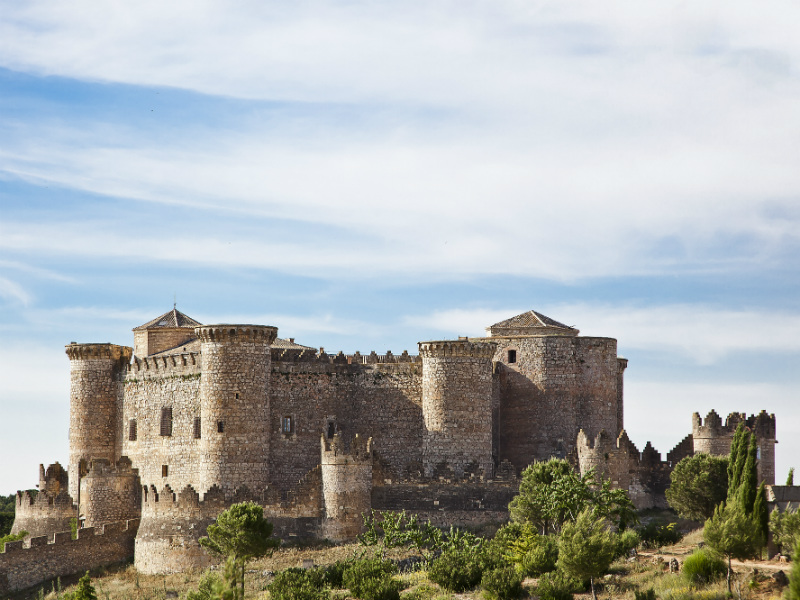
[0,308,775,591]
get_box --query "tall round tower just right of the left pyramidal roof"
[195,325,278,493]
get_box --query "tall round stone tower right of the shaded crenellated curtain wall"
[419,339,497,477]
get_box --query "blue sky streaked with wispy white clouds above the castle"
[0,0,800,494]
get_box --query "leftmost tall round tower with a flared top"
[66,343,133,502]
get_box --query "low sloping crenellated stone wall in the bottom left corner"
[0,521,138,595]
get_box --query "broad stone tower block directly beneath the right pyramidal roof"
[491,336,624,471]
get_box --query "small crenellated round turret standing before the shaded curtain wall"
[321,433,372,542]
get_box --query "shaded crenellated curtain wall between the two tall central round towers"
[269,356,424,491]
